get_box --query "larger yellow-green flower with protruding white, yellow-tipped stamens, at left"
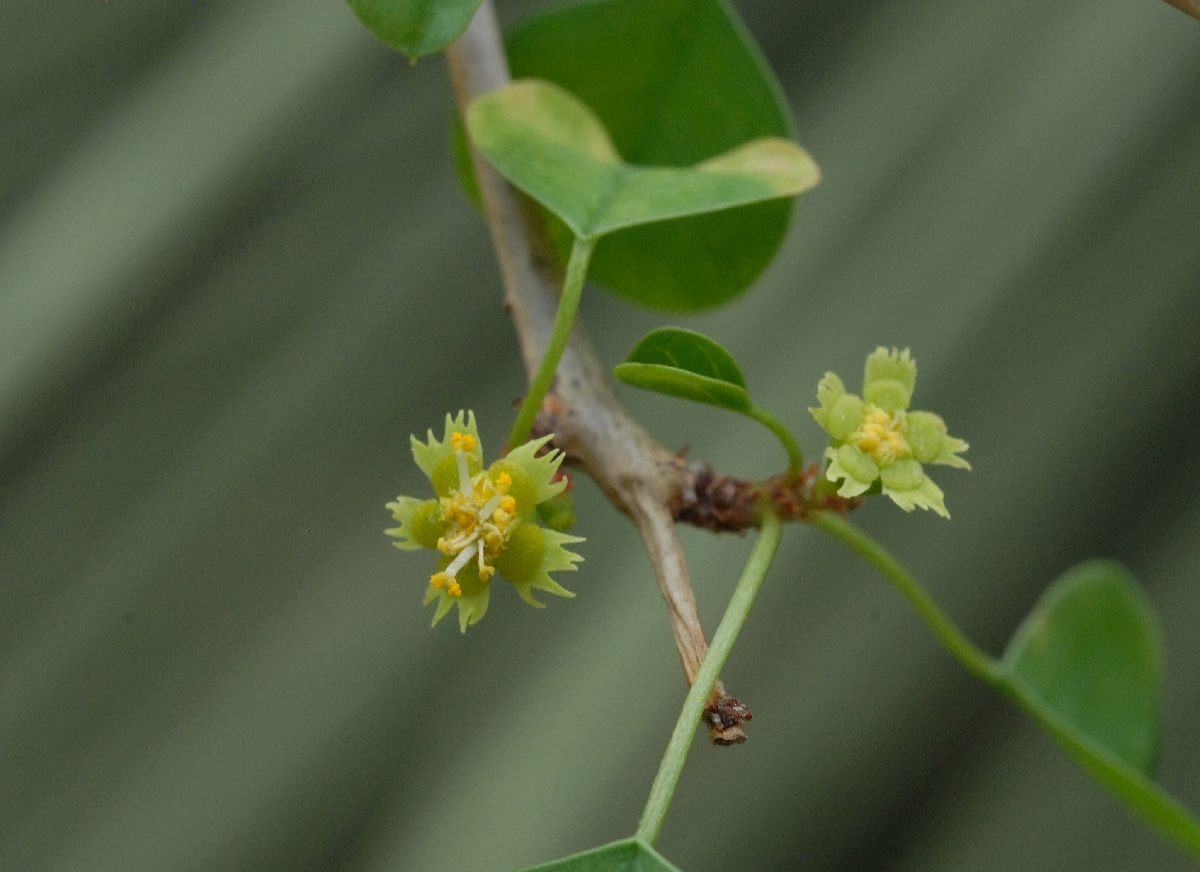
[386,411,583,632]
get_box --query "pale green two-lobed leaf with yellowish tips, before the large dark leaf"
[467,79,820,239]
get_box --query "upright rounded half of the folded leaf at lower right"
[1002,560,1163,772]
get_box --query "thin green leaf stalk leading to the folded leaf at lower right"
[809,511,1004,687]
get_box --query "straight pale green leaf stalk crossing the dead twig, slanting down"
[635,512,782,844]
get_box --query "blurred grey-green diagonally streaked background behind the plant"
[0,0,1200,872]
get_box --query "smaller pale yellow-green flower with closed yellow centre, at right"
[809,347,971,518]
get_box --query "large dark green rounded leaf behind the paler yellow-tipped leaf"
[456,0,811,312]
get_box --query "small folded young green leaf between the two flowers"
[613,327,752,414]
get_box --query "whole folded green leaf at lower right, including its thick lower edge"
[997,560,1200,858]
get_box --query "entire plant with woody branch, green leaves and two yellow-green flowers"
[350,0,1200,870]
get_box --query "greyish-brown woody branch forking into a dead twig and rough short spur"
[446,0,848,744]
